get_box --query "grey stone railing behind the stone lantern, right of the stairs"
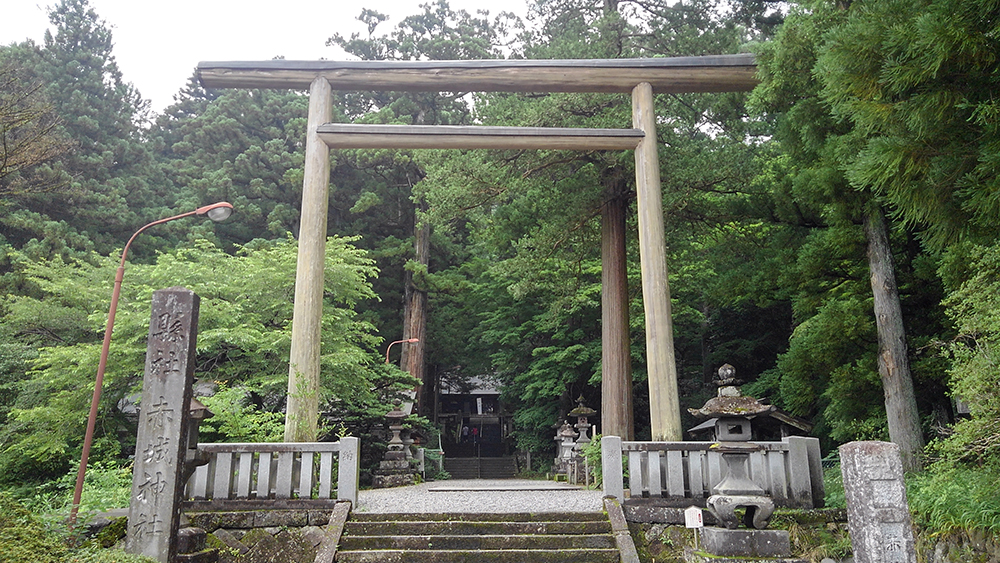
[601,436,824,508]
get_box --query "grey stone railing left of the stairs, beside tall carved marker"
[185,437,361,508]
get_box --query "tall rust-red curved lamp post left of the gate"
[69,201,233,527]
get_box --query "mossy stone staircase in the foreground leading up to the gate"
[336,512,621,563]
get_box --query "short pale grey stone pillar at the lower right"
[840,441,917,563]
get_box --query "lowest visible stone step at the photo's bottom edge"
[337,549,621,563]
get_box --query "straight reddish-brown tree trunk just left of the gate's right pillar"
[601,193,635,440]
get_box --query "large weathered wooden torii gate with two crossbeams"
[197,54,757,441]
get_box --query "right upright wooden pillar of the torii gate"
[632,82,681,440]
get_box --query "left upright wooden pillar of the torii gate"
[285,77,333,442]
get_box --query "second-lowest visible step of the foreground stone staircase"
[340,534,616,551]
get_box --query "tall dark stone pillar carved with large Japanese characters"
[125,287,200,563]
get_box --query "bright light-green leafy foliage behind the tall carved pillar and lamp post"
[0,238,378,483]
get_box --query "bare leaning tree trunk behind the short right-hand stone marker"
[864,208,924,471]
